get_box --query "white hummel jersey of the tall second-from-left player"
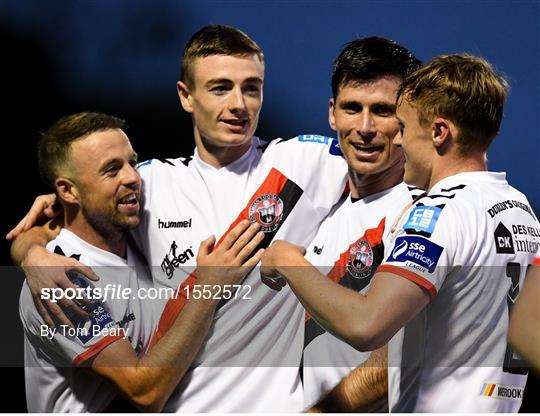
[135,135,347,412]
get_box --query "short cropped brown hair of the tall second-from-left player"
[180,25,264,85]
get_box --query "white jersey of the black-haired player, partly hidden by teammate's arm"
[303,183,419,407]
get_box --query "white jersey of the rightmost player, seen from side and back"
[379,172,540,412]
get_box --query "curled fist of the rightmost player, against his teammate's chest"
[261,240,306,291]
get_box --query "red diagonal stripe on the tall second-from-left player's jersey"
[149,168,288,342]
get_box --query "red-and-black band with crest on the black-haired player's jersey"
[304,218,386,348]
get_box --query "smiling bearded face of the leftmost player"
[71,129,141,233]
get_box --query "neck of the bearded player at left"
[64,210,127,258]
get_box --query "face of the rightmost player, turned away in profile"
[395,99,433,189]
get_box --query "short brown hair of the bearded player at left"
[38,113,126,189]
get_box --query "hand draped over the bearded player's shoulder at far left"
[21,246,99,327]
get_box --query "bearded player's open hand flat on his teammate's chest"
[196,220,264,285]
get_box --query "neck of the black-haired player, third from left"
[349,160,403,198]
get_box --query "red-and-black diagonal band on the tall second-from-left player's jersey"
[150,168,304,346]
